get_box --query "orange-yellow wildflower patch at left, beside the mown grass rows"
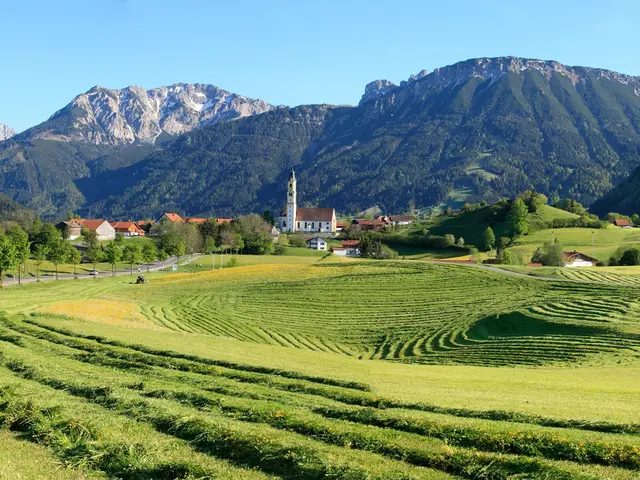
[40,298,162,330]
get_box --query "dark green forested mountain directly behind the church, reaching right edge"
[89,58,640,219]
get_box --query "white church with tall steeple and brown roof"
[278,169,336,233]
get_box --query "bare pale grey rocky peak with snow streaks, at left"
[43,83,274,145]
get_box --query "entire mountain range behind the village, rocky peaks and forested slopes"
[0,57,640,218]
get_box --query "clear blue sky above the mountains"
[0,0,640,131]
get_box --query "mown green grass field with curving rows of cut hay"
[0,257,640,480]
